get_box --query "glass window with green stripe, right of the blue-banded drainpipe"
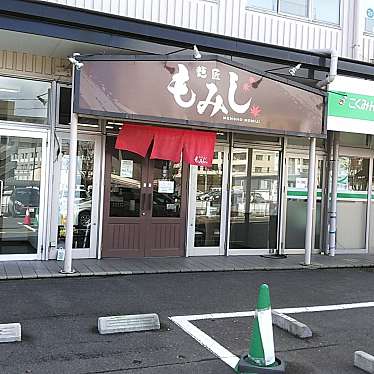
[336,157,369,250]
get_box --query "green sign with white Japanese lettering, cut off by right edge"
[328,91,374,121]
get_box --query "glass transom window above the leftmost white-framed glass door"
[0,77,51,124]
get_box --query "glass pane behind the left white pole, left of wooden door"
[57,139,95,248]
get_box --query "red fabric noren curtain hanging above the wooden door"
[115,123,216,167]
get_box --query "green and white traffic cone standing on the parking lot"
[236,284,285,374]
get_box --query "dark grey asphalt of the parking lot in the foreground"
[0,269,374,374]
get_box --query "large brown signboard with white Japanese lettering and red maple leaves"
[75,60,324,136]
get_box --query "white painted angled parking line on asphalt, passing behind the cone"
[169,302,374,369]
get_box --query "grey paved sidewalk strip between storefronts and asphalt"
[0,254,374,280]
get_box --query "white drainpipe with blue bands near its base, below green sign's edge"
[329,132,339,256]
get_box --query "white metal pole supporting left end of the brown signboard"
[61,64,78,274]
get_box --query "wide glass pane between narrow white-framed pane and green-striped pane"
[230,148,279,249]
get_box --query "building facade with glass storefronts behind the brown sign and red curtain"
[0,0,374,260]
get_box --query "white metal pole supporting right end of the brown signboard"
[304,138,316,265]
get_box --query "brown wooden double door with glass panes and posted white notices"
[103,137,188,257]
